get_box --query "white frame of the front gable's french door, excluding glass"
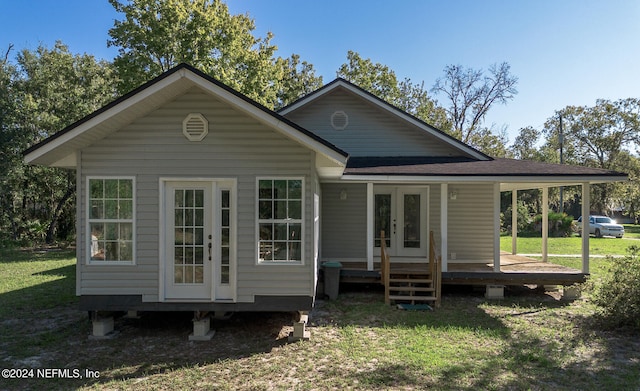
[158,177,237,302]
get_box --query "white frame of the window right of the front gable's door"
[255,176,307,266]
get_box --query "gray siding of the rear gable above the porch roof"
[287,89,461,156]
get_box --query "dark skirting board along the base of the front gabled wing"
[80,295,313,312]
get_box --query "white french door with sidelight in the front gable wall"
[163,180,235,300]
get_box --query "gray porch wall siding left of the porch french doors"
[321,183,367,260]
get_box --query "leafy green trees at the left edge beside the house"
[0,42,115,242]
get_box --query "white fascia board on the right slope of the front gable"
[187,72,347,166]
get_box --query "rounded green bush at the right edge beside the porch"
[592,246,640,329]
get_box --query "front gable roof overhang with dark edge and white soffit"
[23,63,348,168]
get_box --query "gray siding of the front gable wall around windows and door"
[78,89,316,302]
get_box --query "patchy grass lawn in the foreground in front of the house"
[0,250,640,390]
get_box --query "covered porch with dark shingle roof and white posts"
[324,158,628,298]
